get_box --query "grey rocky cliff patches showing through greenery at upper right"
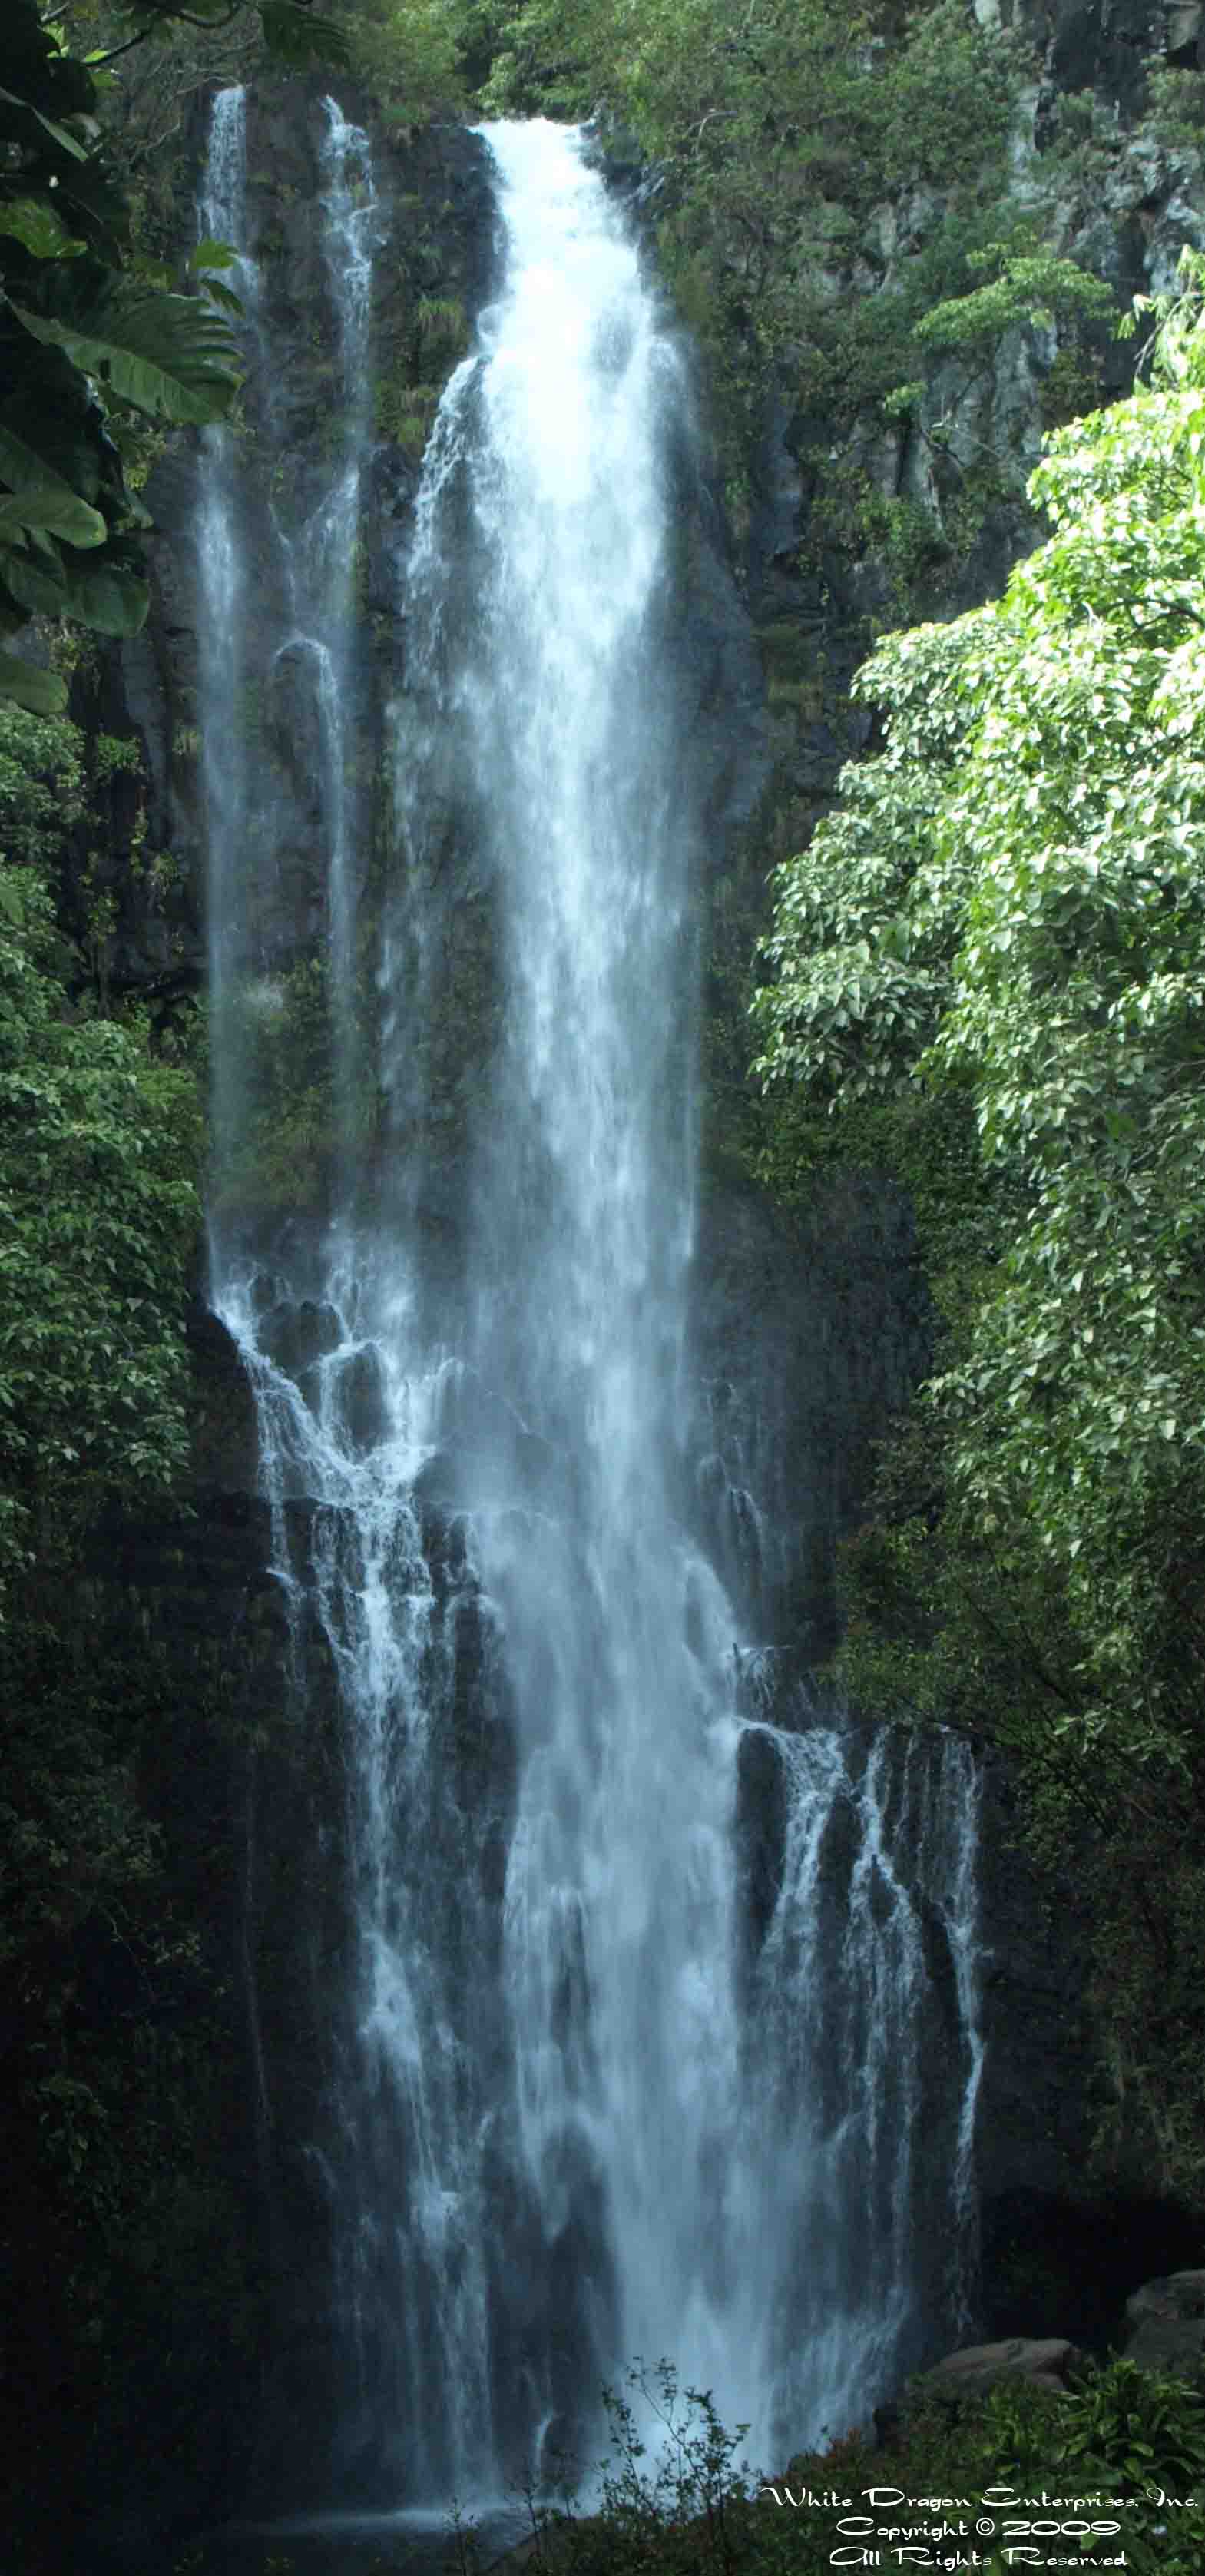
[744,0,1205,847]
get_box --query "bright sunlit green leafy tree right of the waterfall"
[757,263,1205,1767]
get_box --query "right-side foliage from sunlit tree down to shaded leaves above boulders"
[757,263,1205,2192]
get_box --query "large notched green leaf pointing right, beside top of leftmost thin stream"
[13,263,242,423]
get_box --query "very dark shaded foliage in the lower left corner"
[0,1576,274,2568]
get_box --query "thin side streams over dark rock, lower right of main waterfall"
[744,1721,981,2435]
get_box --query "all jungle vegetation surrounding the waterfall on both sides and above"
[0,0,1205,2568]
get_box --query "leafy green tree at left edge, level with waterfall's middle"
[0,706,198,1597]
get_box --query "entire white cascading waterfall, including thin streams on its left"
[201,93,978,2498]
